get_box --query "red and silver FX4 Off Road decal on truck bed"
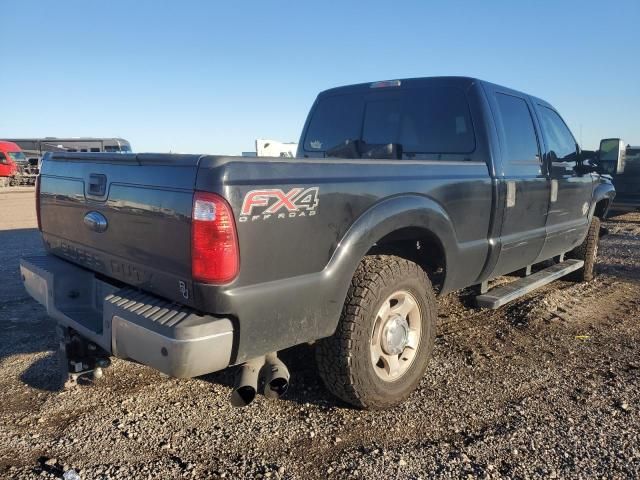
[239,187,320,222]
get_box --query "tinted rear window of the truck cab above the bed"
[303,87,475,154]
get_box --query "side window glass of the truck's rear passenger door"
[496,93,540,165]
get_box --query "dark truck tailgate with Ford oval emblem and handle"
[39,153,200,305]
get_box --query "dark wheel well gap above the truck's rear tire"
[367,227,447,292]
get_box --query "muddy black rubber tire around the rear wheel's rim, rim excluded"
[316,255,437,409]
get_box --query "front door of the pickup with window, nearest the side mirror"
[535,100,593,260]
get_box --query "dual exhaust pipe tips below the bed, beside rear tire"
[230,352,289,407]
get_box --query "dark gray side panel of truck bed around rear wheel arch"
[194,157,494,360]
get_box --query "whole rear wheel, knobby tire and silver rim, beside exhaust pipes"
[316,255,436,408]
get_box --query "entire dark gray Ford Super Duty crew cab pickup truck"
[21,77,620,408]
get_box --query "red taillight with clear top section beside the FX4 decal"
[191,192,240,284]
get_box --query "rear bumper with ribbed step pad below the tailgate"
[20,255,233,378]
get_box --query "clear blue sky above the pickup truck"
[0,0,640,154]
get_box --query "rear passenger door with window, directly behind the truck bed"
[488,86,550,277]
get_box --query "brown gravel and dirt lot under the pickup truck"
[0,191,640,479]
